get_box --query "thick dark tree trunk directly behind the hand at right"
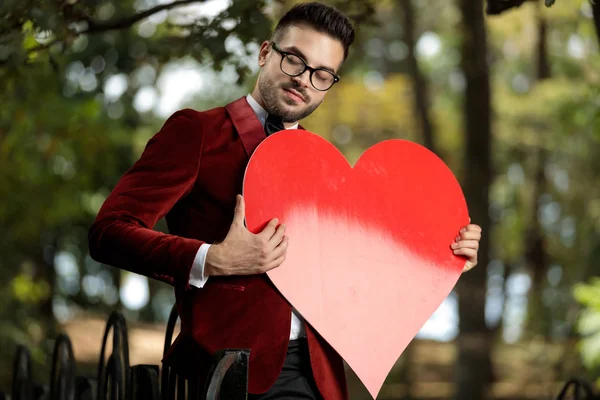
[455,0,492,400]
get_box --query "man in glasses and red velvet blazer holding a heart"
[89,3,480,400]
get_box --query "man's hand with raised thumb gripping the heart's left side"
[204,195,288,276]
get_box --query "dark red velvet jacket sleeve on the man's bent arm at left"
[88,110,204,289]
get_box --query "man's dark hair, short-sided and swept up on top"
[273,2,354,60]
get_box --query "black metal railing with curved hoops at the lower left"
[0,306,250,400]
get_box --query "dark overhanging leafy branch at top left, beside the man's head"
[0,0,271,78]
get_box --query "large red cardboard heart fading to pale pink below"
[243,130,469,398]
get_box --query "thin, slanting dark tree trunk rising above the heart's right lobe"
[398,0,437,154]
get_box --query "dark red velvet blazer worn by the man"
[89,98,347,400]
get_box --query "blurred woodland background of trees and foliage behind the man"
[0,0,600,400]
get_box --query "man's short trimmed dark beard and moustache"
[258,74,320,122]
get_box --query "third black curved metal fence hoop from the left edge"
[96,311,131,400]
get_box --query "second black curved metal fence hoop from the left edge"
[50,334,75,400]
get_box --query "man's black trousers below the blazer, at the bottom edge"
[248,339,322,400]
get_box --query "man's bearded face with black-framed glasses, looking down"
[258,25,344,122]
